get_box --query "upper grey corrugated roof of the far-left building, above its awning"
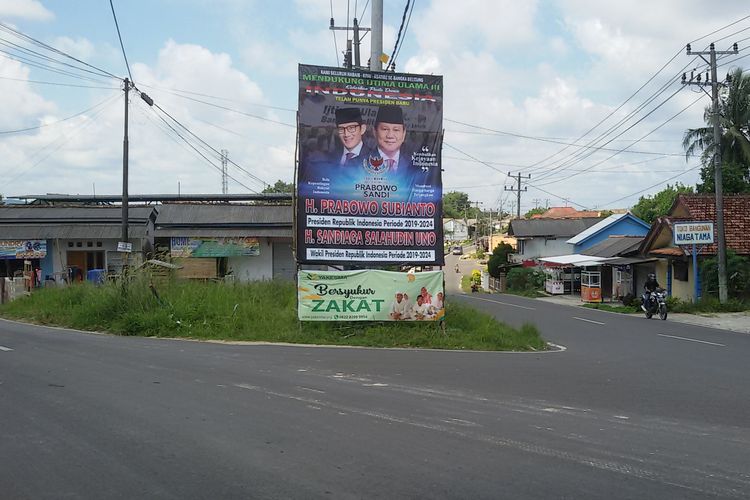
[0,205,156,224]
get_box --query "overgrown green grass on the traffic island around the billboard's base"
[0,279,545,351]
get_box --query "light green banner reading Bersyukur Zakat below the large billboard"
[297,269,445,321]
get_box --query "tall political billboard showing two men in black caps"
[296,65,444,265]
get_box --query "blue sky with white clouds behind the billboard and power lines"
[0,0,750,213]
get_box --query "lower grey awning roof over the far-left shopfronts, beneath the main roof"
[0,224,146,240]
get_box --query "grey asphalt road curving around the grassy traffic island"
[0,278,750,499]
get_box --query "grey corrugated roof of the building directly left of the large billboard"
[156,203,294,228]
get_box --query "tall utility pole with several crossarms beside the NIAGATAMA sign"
[682,43,739,304]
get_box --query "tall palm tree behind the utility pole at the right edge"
[682,68,750,193]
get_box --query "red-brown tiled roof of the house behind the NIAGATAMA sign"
[669,194,750,255]
